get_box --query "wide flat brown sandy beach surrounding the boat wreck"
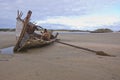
[0,32,120,80]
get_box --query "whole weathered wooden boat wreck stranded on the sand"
[14,10,58,52]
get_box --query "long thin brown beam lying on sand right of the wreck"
[56,40,115,57]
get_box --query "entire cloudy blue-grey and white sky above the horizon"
[0,0,120,31]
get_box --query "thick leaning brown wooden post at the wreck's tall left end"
[14,11,32,51]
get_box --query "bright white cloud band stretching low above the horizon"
[36,15,120,29]
